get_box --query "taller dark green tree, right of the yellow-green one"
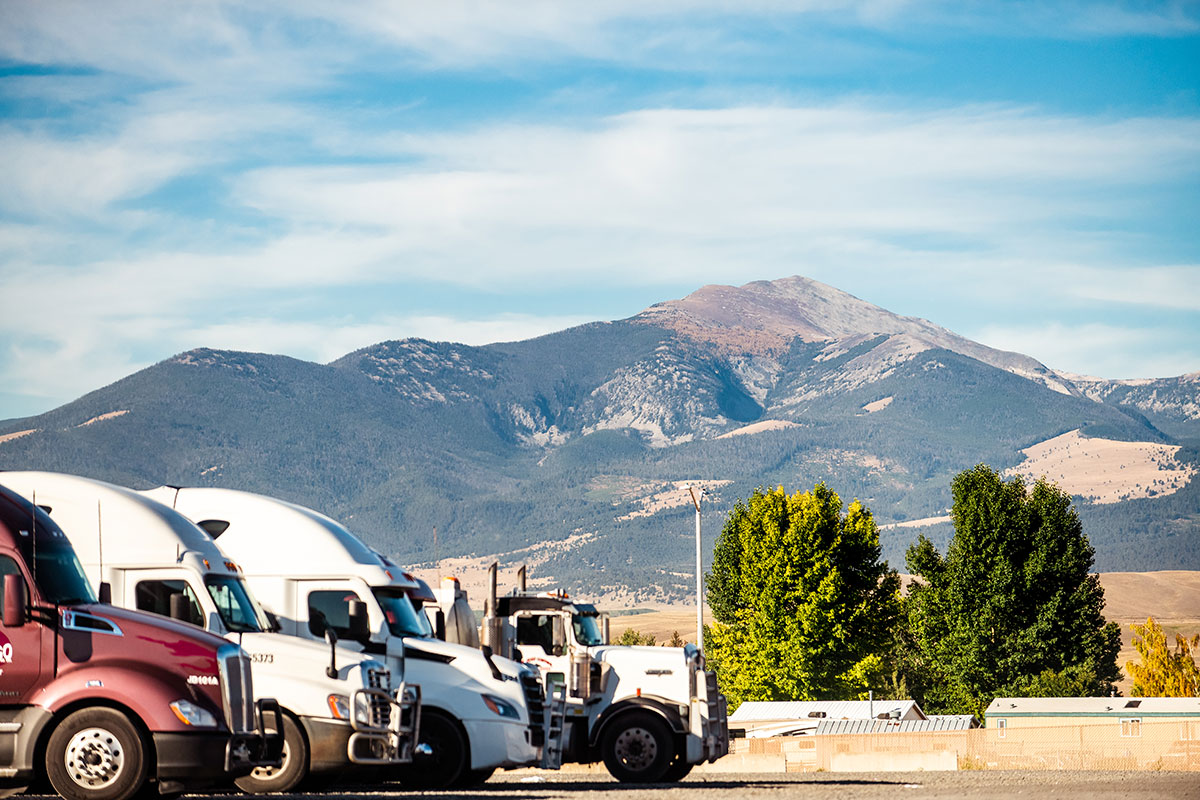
[906,464,1121,715]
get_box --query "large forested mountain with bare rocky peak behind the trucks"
[0,277,1200,600]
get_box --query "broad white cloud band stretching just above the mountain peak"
[226,104,1200,291]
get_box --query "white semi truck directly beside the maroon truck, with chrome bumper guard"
[0,471,420,793]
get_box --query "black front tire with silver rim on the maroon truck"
[46,708,148,800]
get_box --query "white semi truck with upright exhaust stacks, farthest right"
[446,564,730,783]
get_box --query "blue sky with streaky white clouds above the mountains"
[0,0,1200,420]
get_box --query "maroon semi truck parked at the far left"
[0,486,282,800]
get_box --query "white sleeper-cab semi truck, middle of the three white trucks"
[146,487,558,788]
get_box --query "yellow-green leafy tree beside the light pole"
[704,483,900,704]
